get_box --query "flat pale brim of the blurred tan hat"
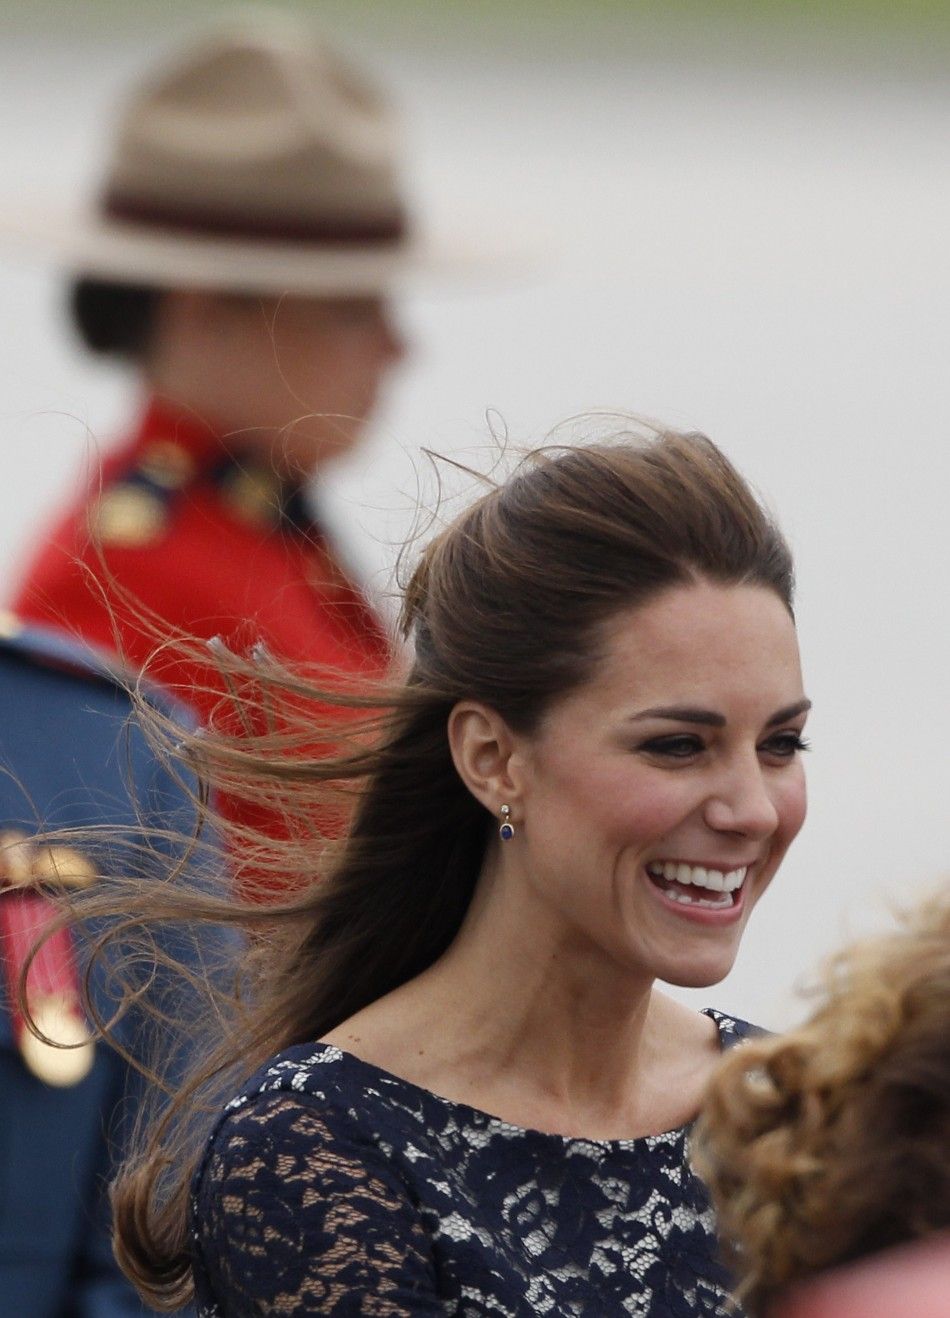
[0,207,519,297]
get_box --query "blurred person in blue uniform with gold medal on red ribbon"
[0,614,224,1318]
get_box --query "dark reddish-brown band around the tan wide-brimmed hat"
[103,192,407,246]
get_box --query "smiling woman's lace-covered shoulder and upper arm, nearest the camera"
[191,1044,441,1314]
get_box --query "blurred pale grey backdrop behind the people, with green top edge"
[0,0,950,1025]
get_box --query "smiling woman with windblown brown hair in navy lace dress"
[83,435,808,1318]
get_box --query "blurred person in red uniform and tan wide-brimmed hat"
[14,13,490,890]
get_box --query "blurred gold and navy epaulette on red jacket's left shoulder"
[88,439,196,548]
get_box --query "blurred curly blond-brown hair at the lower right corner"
[694,895,950,1314]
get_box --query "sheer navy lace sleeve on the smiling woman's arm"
[194,1093,444,1318]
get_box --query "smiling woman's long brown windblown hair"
[79,434,792,1307]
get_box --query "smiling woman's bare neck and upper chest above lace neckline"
[327,880,718,1139]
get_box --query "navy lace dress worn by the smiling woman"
[192,1011,750,1318]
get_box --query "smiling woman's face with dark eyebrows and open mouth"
[502,581,808,987]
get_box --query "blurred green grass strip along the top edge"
[0,0,950,67]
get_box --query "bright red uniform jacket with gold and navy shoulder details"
[13,403,390,896]
